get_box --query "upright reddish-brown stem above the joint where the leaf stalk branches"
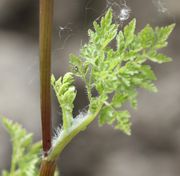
[39,0,53,156]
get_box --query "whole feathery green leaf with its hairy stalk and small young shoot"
[48,9,175,160]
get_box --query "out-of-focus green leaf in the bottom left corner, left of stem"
[2,118,41,176]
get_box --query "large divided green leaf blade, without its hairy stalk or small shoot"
[70,9,175,134]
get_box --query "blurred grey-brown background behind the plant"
[0,0,180,176]
